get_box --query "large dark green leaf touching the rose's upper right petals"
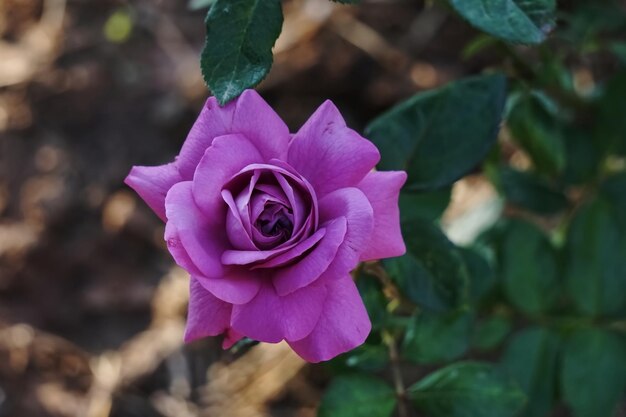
[366,74,506,190]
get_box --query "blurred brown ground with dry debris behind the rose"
[0,0,620,417]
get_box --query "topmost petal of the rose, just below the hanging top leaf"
[232,90,290,162]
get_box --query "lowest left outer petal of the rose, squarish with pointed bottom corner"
[185,278,232,342]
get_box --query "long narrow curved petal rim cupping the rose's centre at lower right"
[272,217,346,296]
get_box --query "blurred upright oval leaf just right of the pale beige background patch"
[500,220,558,314]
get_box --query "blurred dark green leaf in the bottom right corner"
[561,329,626,417]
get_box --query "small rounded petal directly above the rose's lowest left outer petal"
[195,267,266,304]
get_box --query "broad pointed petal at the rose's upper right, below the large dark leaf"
[287,101,380,197]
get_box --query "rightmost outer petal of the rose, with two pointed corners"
[358,171,406,261]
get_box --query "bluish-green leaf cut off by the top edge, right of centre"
[450,0,556,44]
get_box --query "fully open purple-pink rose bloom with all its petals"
[126,90,406,362]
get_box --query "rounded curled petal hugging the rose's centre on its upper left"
[193,135,262,222]
